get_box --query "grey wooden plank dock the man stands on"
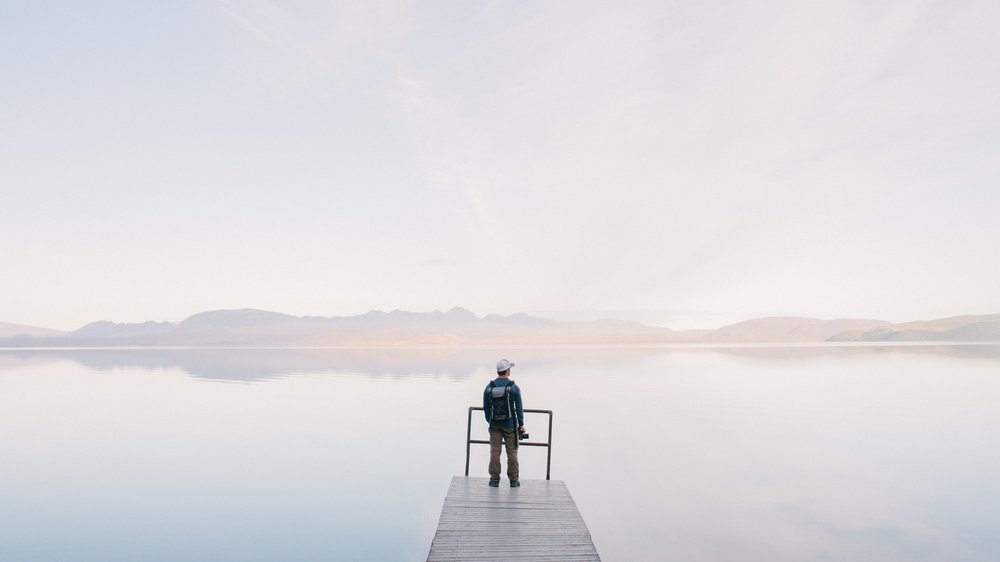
[427,476,601,562]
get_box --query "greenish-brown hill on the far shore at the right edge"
[830,314,1000,342]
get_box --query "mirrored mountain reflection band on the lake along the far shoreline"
[0,344,1000,382]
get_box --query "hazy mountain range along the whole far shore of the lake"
[0,308,1000,347]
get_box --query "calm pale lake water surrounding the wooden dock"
[0,345,1000,561]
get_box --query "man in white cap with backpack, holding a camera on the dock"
[483,359,524,488]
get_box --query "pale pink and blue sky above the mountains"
[0,0,1000,329]
